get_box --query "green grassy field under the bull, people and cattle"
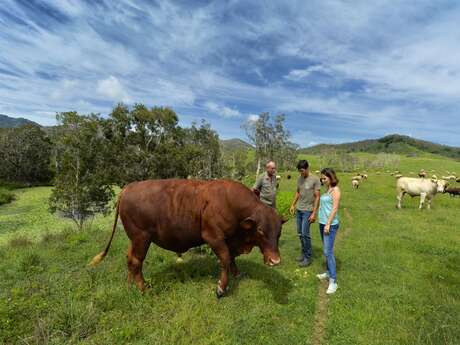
[0,156,460,345]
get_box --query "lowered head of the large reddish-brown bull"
[241,205,285,266]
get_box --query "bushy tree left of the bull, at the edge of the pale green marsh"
[49,112,114,229]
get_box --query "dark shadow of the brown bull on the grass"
[146,256,292,304]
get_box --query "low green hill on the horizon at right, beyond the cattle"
[300,134,460,160]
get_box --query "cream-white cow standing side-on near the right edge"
[396,177,448,209]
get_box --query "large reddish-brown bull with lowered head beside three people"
[91,180,283,297]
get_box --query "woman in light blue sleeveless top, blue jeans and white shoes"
[317,168,340,294]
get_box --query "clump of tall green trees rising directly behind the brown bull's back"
[103,104,222,183]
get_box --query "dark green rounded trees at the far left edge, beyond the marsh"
[0,124,52,184]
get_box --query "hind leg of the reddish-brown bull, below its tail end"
[128,233,150,292]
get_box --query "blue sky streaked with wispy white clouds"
[0,0,460,146]
